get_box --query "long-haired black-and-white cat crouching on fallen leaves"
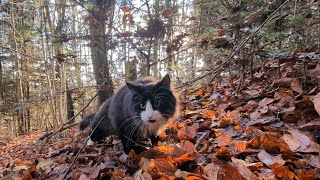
[79,74,178,154]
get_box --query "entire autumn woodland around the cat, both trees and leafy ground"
[0,0,320,180]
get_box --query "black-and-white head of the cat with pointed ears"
[127,74,177,125]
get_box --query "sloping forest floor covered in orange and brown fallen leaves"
[0,60,320,180]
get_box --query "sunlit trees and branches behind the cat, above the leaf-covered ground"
[0,0,320,141]
